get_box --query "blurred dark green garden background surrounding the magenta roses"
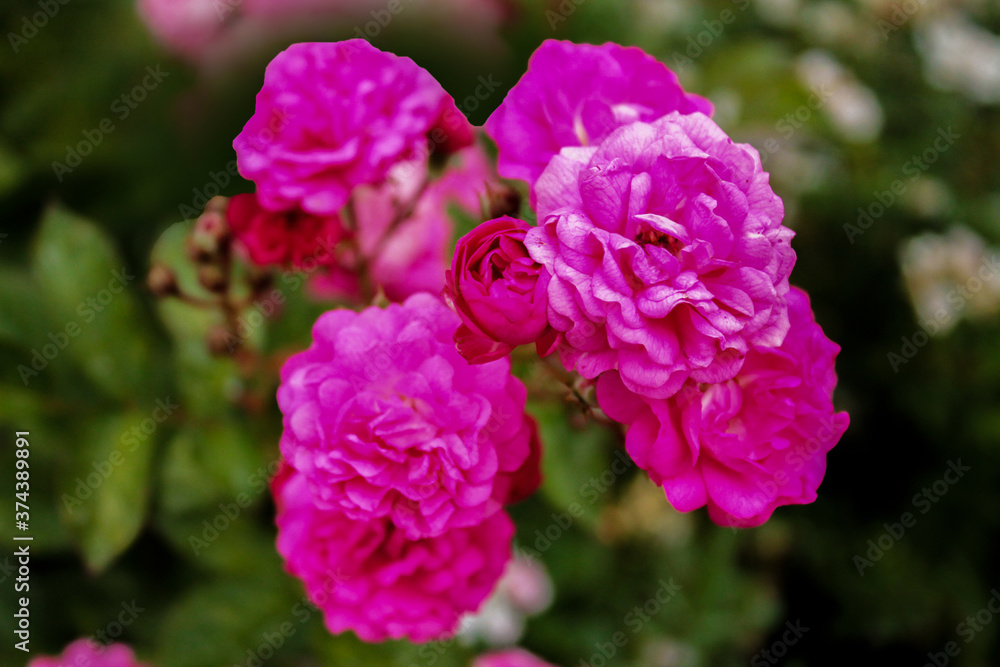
[0,0,1000,667]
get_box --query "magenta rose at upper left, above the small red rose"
[233,39,472,215]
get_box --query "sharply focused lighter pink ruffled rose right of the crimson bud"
[525,113,795,398]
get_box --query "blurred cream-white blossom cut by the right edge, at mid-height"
[900,227,1000,334]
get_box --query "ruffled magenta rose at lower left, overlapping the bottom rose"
[278,294,533,539]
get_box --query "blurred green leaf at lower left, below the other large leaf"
[60,412,160,572]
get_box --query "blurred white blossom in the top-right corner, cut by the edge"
[915,10,1000,104]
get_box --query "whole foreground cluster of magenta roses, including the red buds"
[227,35,848,648]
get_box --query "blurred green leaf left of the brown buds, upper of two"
[33,207,149,400]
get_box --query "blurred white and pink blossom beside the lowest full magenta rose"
[458,554,554,646]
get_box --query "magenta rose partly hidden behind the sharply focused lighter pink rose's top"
[484,39,712,193]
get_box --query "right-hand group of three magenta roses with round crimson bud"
[446,40,848,526]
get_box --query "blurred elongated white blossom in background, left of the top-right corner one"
[795,49,884,143]
